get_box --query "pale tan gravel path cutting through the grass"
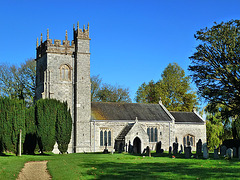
[17,161,52,180]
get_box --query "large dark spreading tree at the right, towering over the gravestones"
[189,20,240,117]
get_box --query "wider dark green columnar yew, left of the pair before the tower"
[36,99,57,152]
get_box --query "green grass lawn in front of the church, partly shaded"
[0,154,240,180]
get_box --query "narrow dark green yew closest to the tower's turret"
[56,101,72,154]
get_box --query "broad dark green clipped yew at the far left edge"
[0,97,26,154]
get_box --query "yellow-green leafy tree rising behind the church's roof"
[136,63,198,111]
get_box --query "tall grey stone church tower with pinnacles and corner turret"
[36,23,91,153]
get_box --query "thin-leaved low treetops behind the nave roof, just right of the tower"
[91,75,132,102]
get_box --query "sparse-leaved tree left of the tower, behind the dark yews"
[0,59,36,106]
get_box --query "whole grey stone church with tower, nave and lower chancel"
[36,23,206,153]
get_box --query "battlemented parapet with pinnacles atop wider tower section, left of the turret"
[37,30,75,58]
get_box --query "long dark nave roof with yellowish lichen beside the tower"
[91,102,171,121]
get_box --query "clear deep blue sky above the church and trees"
[0,0,240,105]
